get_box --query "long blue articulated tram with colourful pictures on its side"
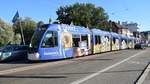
[28,24,136,61]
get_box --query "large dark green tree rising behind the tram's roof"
[56,3,108,28]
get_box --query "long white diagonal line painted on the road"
[70,51,145,84]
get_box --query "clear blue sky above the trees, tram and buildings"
[0,0,150,31]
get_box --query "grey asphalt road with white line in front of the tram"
[0,48,150,84]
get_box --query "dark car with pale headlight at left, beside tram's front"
[0,44,28,61]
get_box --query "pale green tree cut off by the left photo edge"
[0,19,14,46]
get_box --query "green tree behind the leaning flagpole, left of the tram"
[13,17,36,45]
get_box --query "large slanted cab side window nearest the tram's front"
[42,31,58,48]
